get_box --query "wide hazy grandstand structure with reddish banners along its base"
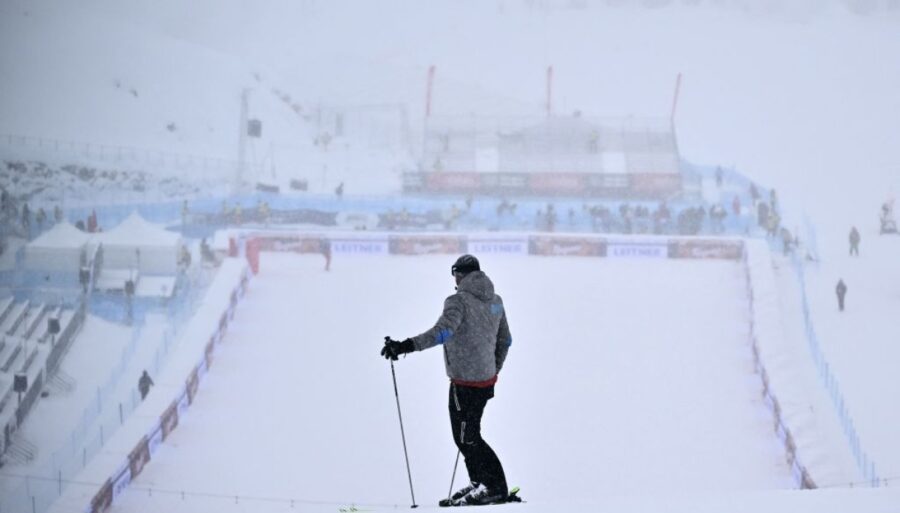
[403,113,682,200]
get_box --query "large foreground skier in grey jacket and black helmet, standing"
[381,255,512,506]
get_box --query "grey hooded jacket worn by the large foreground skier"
[413,271,512,382]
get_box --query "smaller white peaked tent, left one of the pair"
[25,221,91,273]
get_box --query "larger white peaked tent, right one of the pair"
[95,212,182,275]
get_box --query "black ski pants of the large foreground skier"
[450,384,509,494]
